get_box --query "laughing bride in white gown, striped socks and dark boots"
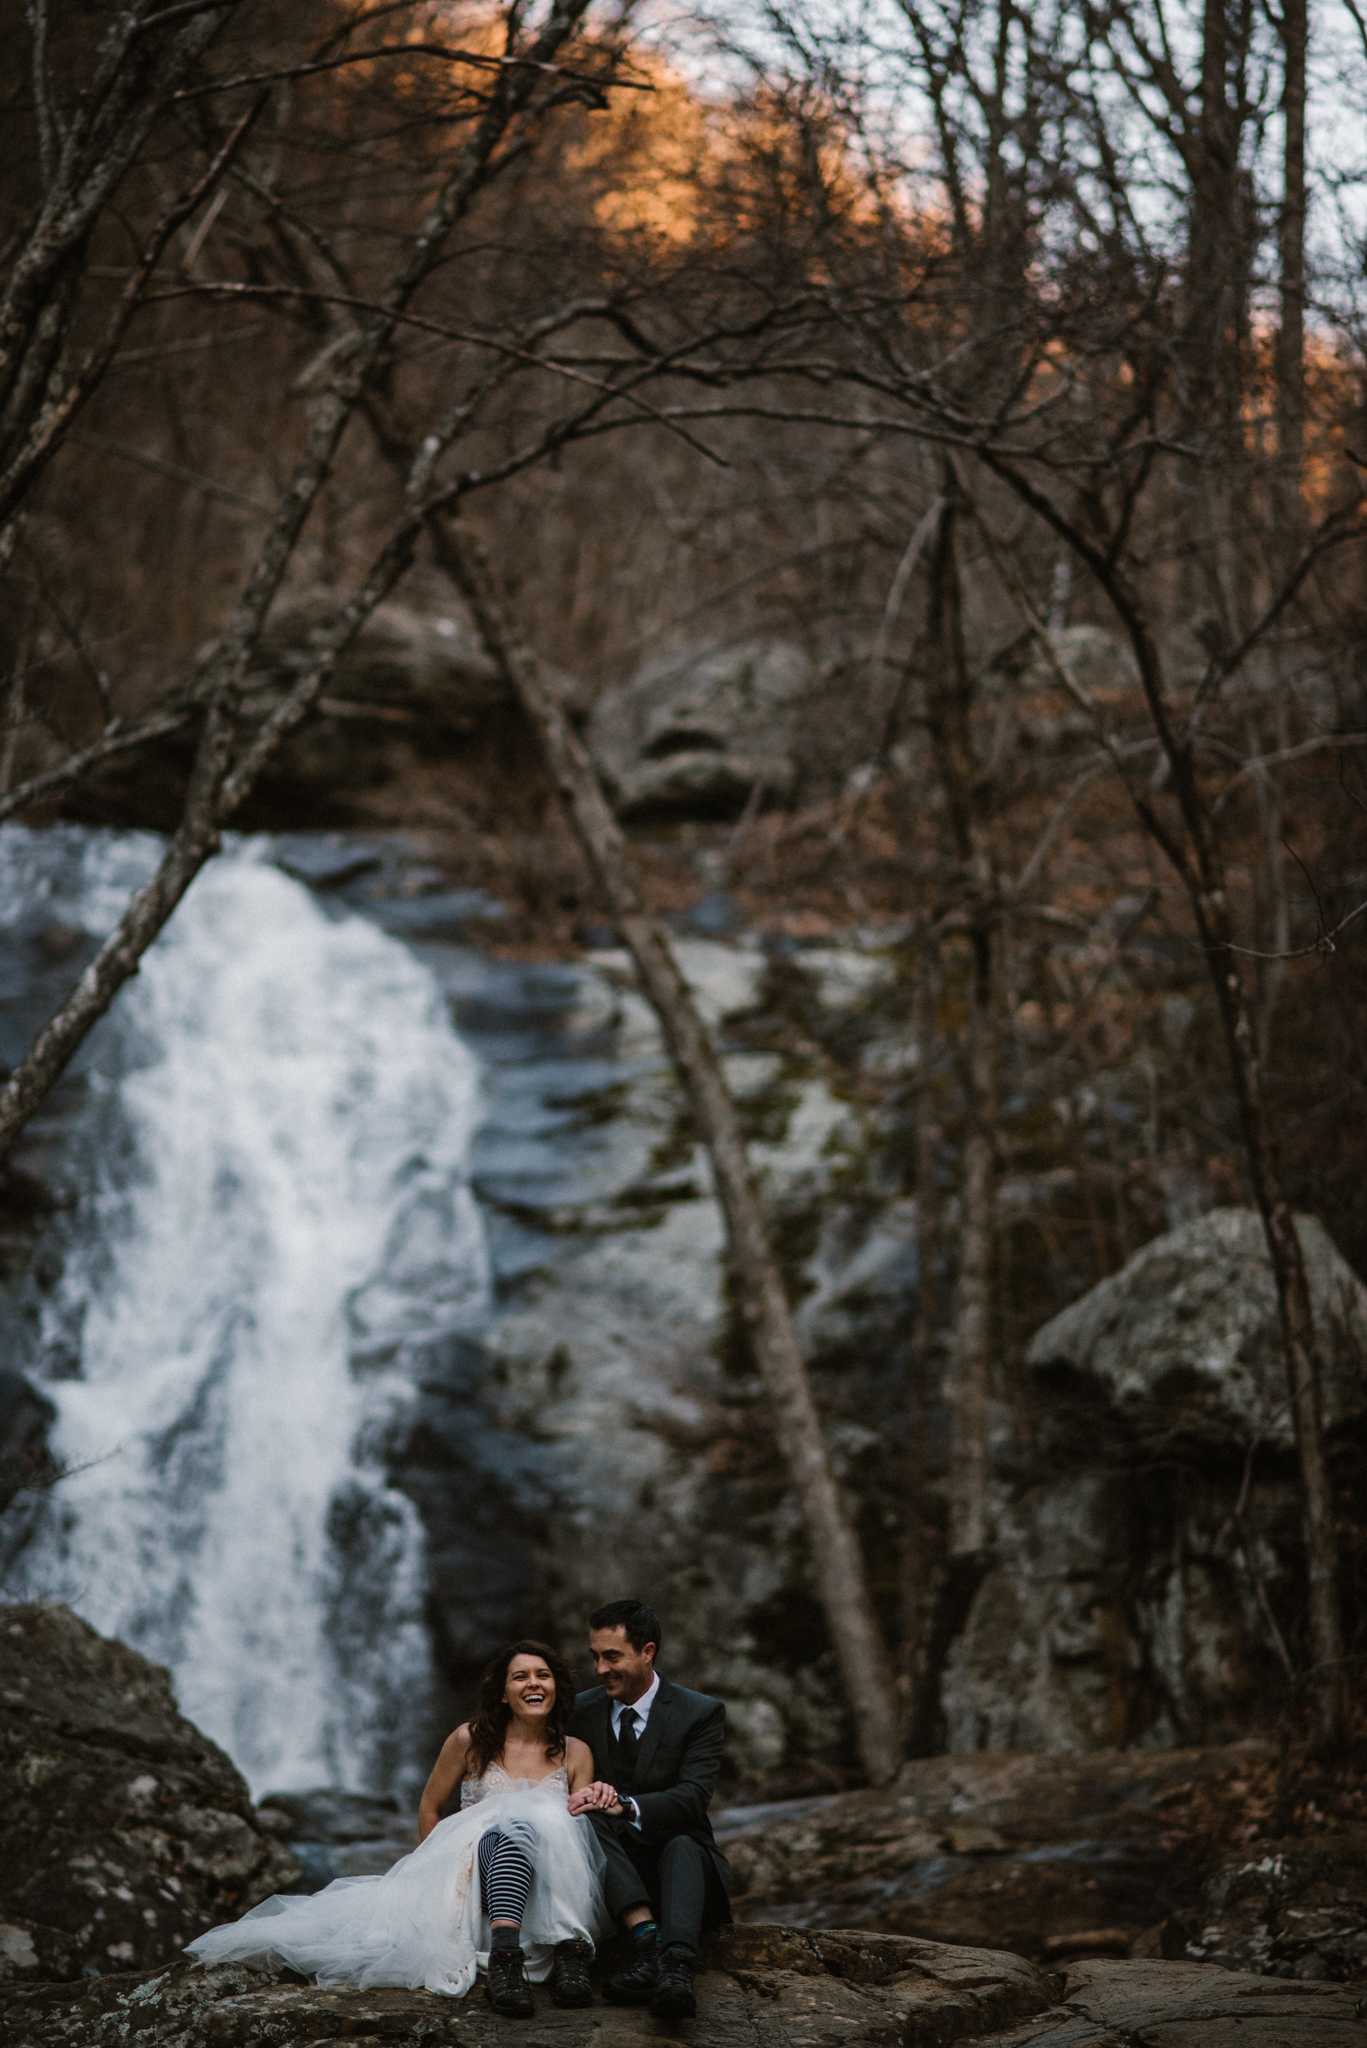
[187,1642,611,2019]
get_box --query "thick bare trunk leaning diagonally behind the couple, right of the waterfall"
[430,518,900,1784]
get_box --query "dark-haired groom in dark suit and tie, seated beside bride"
[570,1599,732,2019]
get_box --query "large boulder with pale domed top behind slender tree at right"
[941,1208,1367,1751]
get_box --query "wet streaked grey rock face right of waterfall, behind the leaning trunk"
[393,938,889,1778]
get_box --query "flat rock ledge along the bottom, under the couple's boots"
[10,1927,1367,2048]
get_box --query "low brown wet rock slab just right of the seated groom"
[726,1743,1267,1962]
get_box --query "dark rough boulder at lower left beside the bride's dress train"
[0,1606,299,1980]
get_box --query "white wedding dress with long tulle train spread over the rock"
[184,1763,611,1999]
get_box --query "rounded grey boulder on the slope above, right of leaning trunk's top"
[588,641,814,817]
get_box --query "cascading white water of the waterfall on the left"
[0,829,486,1794]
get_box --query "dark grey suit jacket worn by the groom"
[572,1675,732,1896]
